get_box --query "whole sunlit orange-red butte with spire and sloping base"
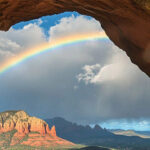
[0,111,74,147]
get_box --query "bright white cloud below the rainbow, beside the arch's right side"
[77,46,141,84]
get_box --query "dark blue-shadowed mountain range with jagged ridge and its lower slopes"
[45,117,150,150]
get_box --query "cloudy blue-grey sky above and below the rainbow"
[0,12,150,130]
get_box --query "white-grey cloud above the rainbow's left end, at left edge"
[0,20,46,62]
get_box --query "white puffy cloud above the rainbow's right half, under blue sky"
[49,15,102,40]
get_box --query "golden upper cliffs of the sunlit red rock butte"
[0,111,53,134]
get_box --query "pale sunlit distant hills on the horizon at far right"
[110,129,150,138]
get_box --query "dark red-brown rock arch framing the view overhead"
[0,0,150,76]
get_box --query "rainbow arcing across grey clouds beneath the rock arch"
[0,32,108,74]
